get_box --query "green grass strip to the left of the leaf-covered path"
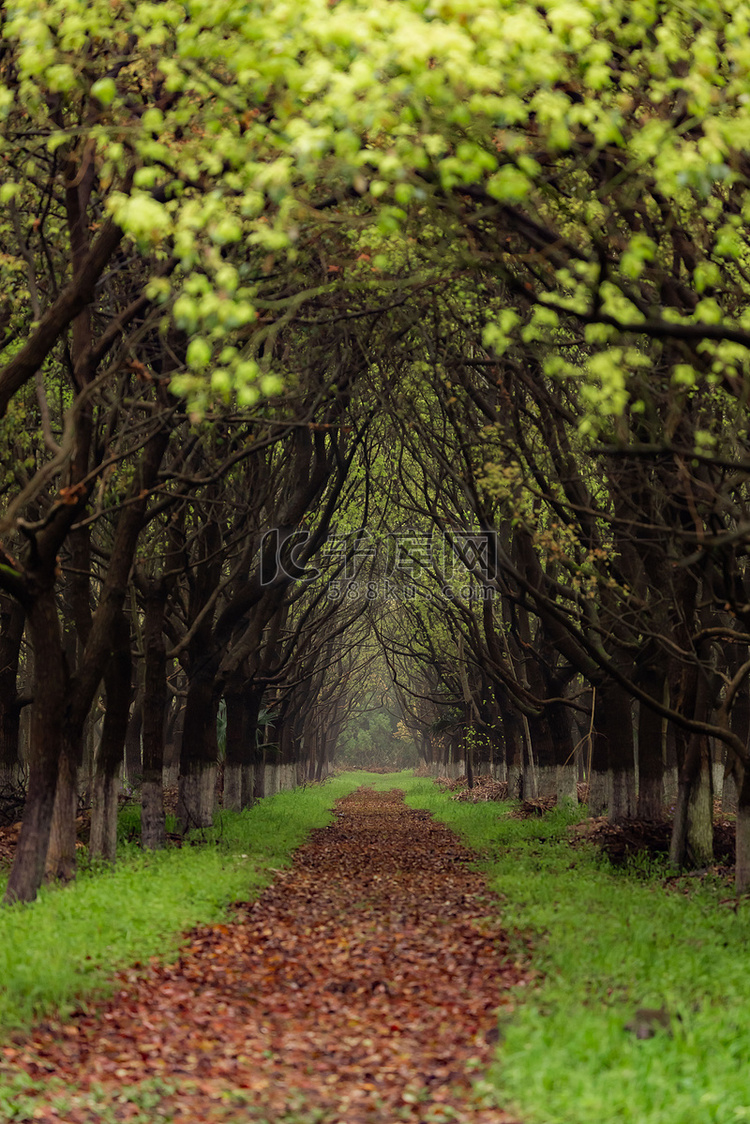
[0,774,362,1036]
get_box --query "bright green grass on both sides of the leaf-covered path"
[7,772,750,1124]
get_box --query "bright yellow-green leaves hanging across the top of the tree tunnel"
[5,0,750,415]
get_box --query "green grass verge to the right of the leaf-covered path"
[391,779,750,1124]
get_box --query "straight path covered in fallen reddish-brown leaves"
[6,789,526,1124]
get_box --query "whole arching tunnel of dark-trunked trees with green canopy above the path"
[0,3,750,901]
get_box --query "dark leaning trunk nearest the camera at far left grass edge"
[3,587,67,904]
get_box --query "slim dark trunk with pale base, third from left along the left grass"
[89,613,132,862]
